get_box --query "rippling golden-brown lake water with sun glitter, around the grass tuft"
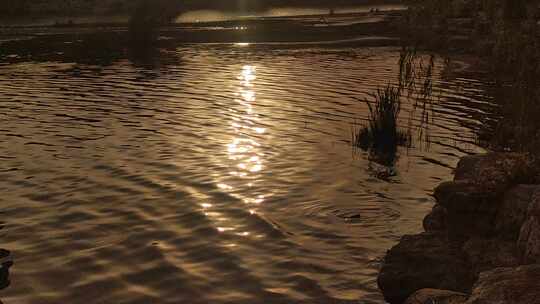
[0,45,490,304]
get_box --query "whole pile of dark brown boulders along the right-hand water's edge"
[378,153,540,304]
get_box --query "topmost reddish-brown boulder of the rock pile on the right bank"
[454,153,536,193]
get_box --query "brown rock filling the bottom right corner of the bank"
[466,265,540,304]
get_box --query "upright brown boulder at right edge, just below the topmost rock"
[495,185,540,241]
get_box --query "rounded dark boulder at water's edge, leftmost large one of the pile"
[377,233,474,304]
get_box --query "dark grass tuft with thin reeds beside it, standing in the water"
[352,47,435,166]
